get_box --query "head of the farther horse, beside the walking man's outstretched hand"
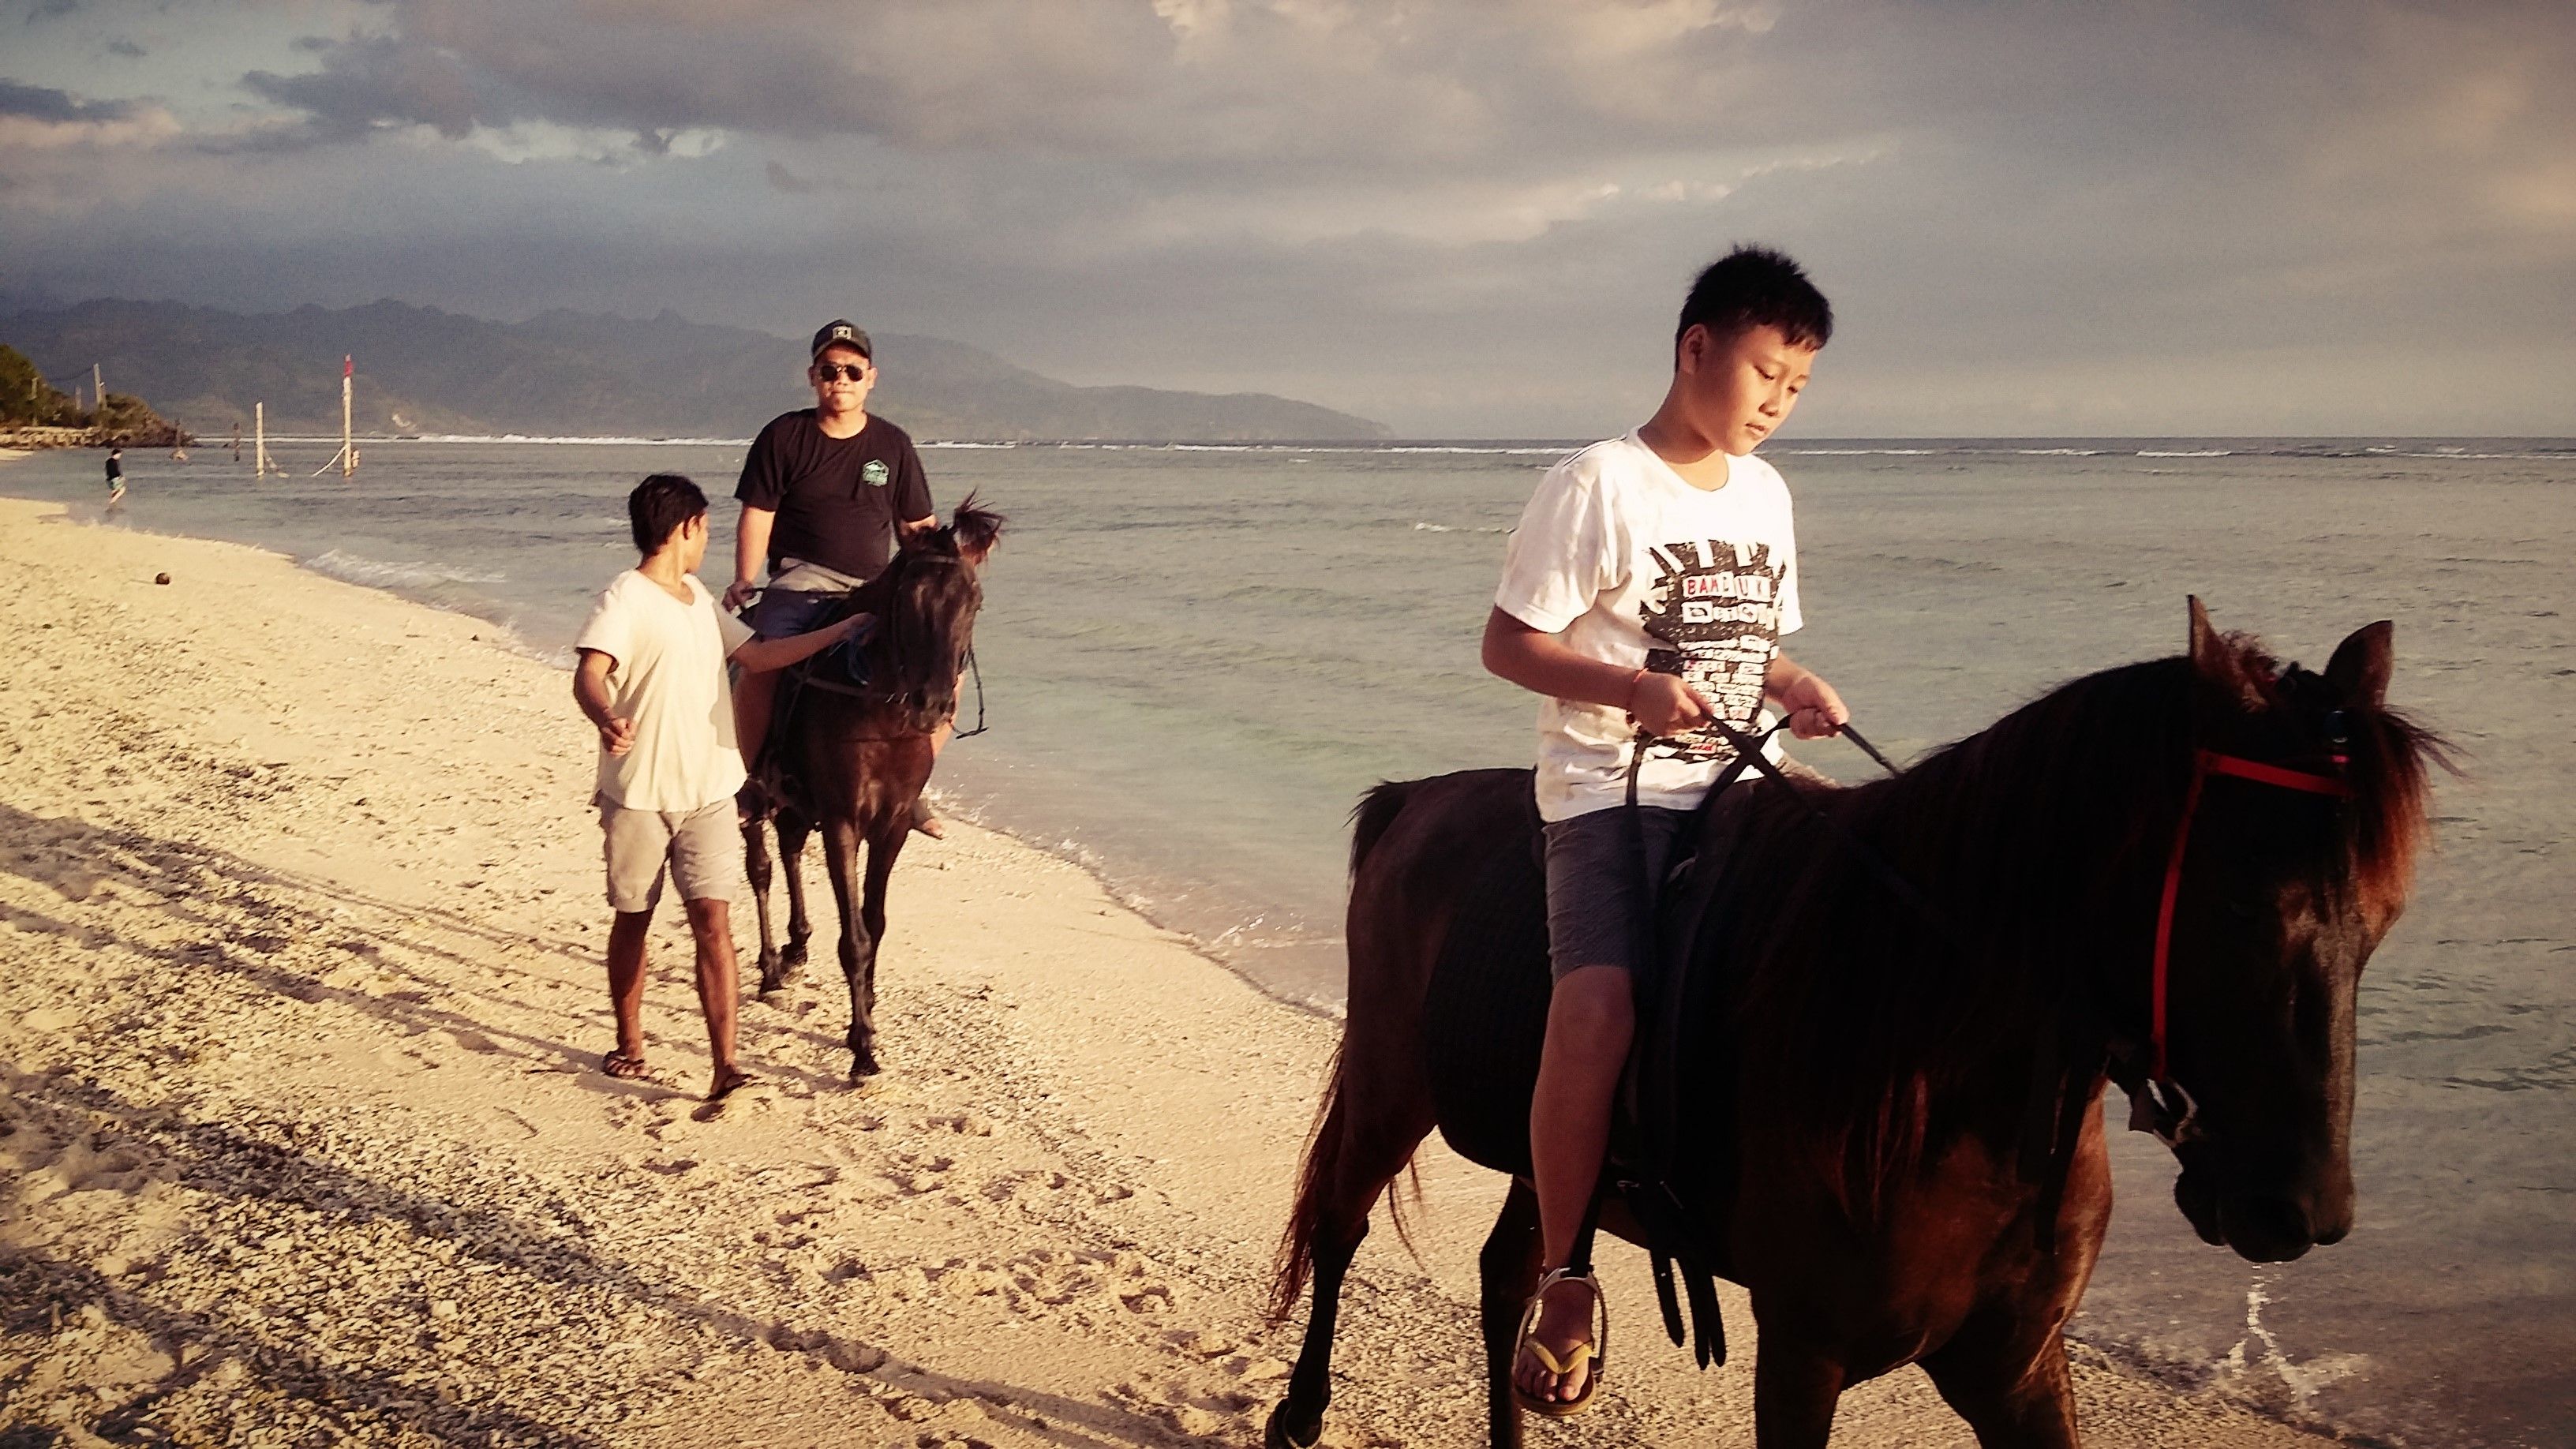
[868,495,1005,735]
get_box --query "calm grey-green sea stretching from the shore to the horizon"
[0,438,2576,1443]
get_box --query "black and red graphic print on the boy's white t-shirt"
[1638,539,1788,761]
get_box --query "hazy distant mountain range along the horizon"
[0,301,1388,441]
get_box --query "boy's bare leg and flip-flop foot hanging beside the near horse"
[1512,967,1636,1402]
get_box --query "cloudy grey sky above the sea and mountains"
[0,0,2576,436]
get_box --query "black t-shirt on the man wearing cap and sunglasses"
[734,407,930,578]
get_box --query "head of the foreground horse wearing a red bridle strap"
[2120,598,2442,1264]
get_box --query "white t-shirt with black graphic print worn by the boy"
[1494,433,1801,820]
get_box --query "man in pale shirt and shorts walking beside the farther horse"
[572,472,858,1101]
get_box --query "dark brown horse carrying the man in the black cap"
[742,498,1005,1080]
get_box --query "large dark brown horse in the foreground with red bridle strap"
[1270,601,2442,1449]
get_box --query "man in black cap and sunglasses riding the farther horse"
[724,320,940,835]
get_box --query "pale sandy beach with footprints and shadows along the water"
[0,489,2321,1449]
